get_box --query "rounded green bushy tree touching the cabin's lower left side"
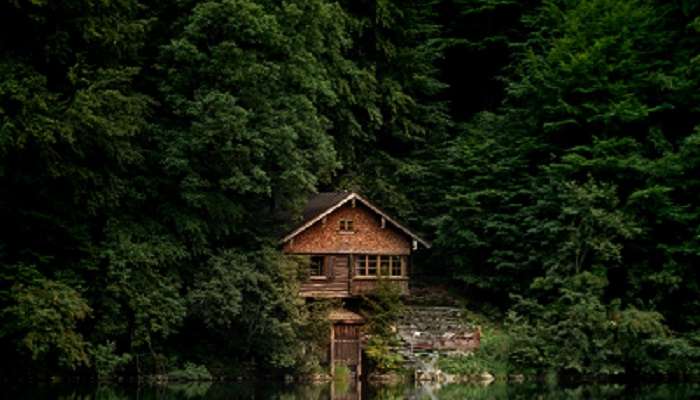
[189,249,309,368]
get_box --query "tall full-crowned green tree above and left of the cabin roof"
[157,1,347,222]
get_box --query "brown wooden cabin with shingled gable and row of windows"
[282,192,430,298]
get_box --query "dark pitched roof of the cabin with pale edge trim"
[282,192,430,248]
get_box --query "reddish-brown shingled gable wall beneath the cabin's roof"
[283,203,411,255]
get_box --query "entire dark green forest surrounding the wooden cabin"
[0,0,700,379]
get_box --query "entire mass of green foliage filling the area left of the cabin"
[0,0,382,375]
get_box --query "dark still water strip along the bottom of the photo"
[5,383,700,400]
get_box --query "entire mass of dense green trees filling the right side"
[437,0,700,375]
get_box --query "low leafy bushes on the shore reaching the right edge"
[508,273,700,376]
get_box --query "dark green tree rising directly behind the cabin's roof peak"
[332,0,449,226]
